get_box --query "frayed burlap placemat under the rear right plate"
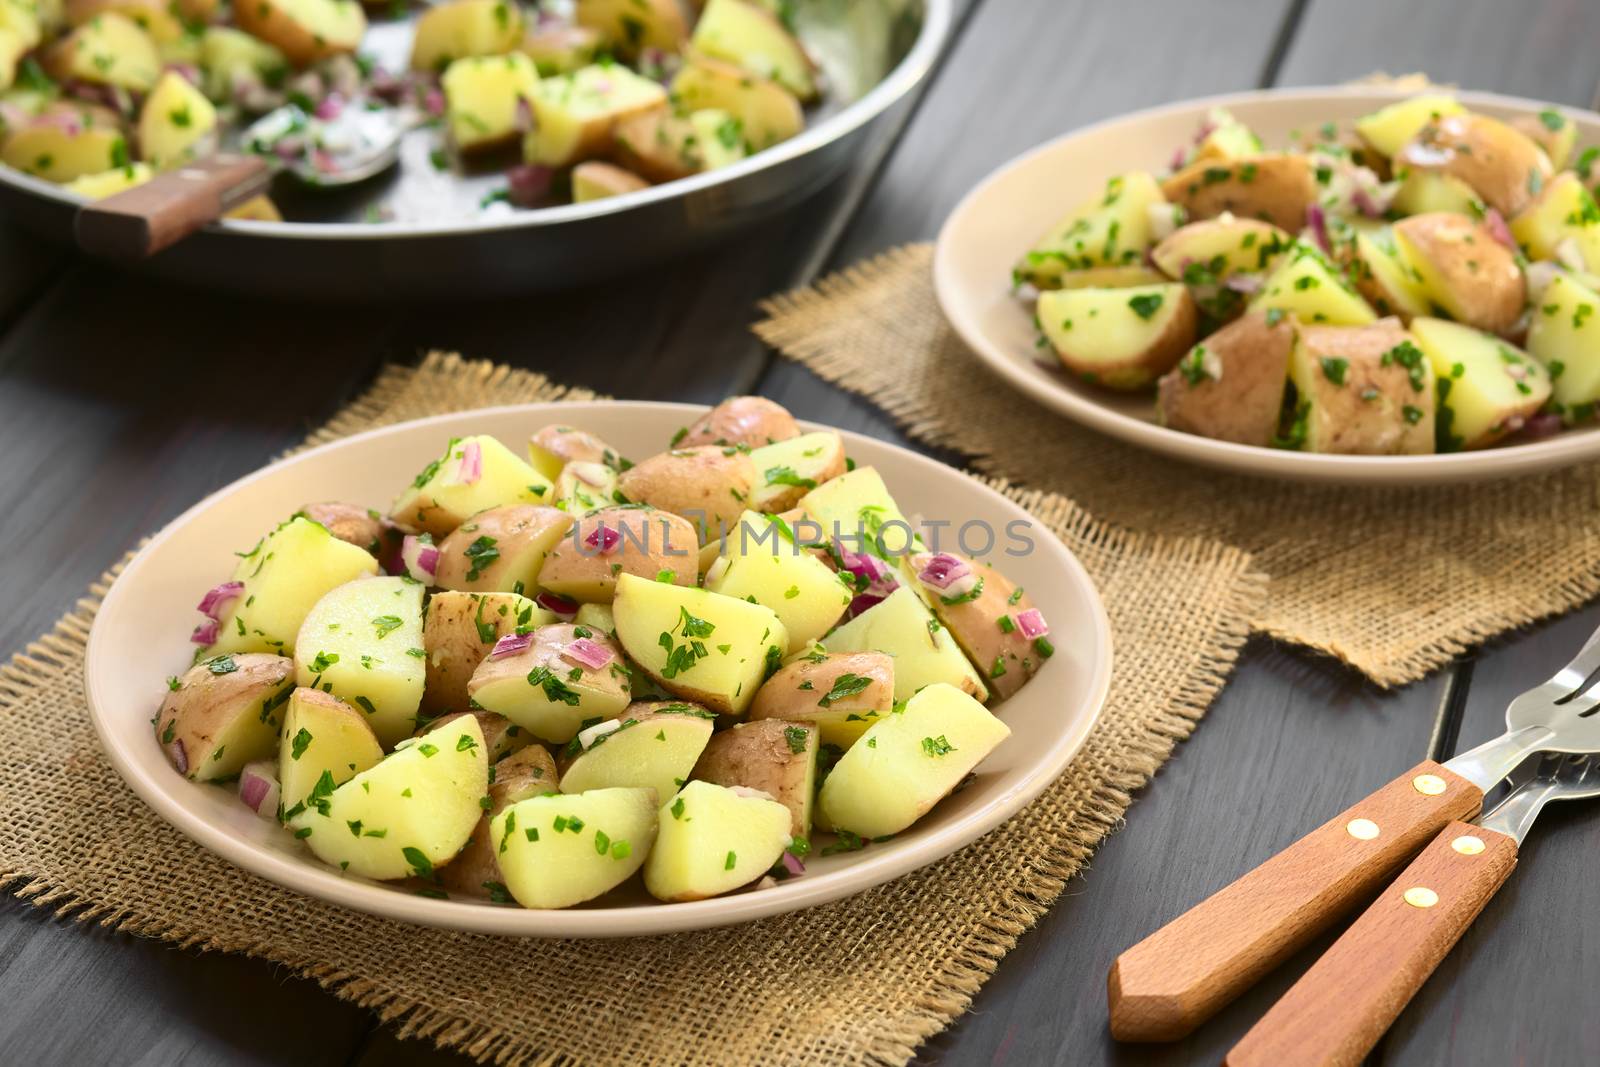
[755,245,1600,686]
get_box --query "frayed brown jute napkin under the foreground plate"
[0,355,1262,1067]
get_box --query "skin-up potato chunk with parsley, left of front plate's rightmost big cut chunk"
[750,646,894,749]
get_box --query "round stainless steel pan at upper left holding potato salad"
[0,0,952,299]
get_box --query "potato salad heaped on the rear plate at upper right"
[1013,93,1600,454]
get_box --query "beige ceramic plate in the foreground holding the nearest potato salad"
[83,403,1110,937]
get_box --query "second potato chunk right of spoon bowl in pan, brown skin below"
[522,64,667,166]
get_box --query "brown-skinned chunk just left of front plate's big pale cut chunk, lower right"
[694,718,819,838]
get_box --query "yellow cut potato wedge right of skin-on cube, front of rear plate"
[1411,318,1550,453]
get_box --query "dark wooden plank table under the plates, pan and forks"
[0,0,1600,1067]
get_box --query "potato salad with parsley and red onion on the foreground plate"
[154,397,1054,909]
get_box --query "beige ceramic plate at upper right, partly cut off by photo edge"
[934,88,1600,485]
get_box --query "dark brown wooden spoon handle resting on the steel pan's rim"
[75,152,272,262]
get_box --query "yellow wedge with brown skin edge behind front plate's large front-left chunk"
[278,688,384,819]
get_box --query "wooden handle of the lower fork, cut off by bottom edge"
[1226,822,1517,1067]
